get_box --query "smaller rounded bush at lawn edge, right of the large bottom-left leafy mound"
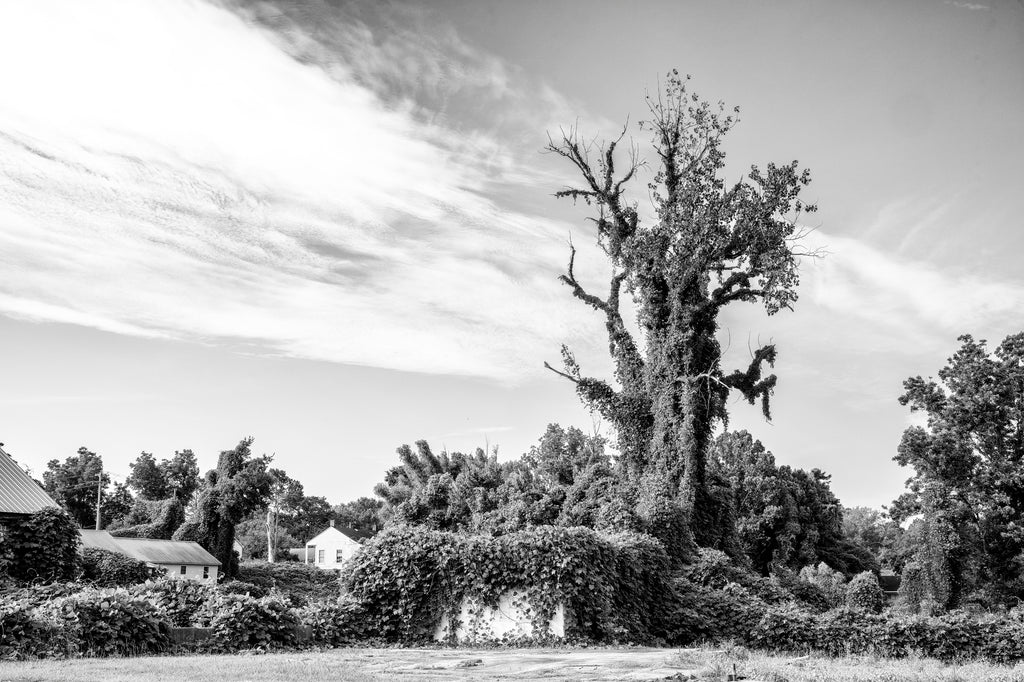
[205,594,299,652]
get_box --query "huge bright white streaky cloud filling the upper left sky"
[0,0,598,380]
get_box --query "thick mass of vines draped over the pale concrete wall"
[342,527,673,642]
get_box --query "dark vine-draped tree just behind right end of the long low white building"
[174,437,271,579]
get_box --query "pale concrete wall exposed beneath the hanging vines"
[434,590,565,643]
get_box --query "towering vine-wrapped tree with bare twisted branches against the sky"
[548,71,815,557]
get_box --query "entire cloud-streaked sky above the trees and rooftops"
[0,0,1024,507]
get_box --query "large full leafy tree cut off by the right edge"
[892,332,1024,607]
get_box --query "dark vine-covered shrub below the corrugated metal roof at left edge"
[0,507,79,583]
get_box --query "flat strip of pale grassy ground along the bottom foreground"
[0,648,1024,682]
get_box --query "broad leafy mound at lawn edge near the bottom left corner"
[37,588,171,656]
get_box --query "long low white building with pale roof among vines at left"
[79,530,220,583]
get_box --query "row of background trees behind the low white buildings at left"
[42,437,383,578]
